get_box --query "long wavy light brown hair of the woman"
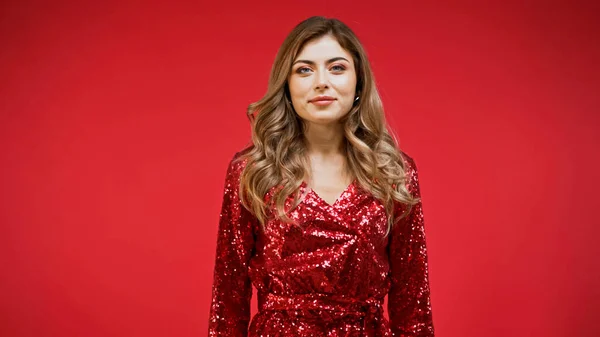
[238,16,419,236]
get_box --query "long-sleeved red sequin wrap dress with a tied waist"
[208,153,434,337]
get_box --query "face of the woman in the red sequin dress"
[288,35,356,124]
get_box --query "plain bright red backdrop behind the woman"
[0,0,600,337]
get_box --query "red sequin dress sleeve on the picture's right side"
[388,157,434,337]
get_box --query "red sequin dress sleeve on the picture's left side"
[208,154,258,337]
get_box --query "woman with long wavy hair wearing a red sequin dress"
[209,17,434,337]
